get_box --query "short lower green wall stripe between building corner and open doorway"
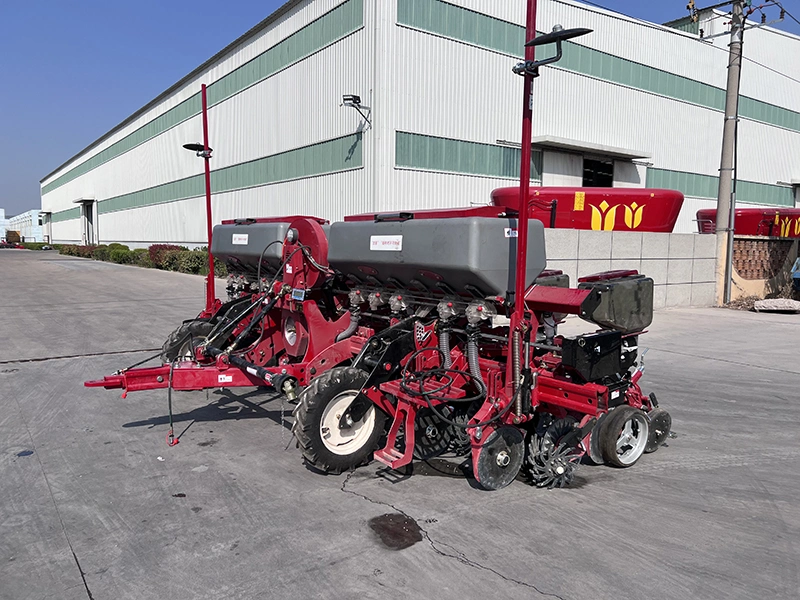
[395,131,542,181]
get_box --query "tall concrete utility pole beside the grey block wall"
[716,0,744,304]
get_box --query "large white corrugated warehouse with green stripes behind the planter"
[41,0,800,246]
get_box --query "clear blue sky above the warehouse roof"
[0,0,800,215]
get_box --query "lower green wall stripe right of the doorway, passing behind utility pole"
[647,169,794,207]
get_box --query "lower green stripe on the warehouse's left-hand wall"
[97,133,364,214]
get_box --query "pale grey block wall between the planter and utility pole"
[545,229,716,309]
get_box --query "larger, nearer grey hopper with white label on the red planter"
[328,217,546,296]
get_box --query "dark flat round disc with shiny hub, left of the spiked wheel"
[475,425,525,490]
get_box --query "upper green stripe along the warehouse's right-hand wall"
[397,0,800,131]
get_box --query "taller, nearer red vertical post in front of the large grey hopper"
[513,0,536,327]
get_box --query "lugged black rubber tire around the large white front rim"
[294,367,387,474]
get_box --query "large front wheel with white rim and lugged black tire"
[294,367,386,473]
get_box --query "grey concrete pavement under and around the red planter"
[0,251,800,600]
